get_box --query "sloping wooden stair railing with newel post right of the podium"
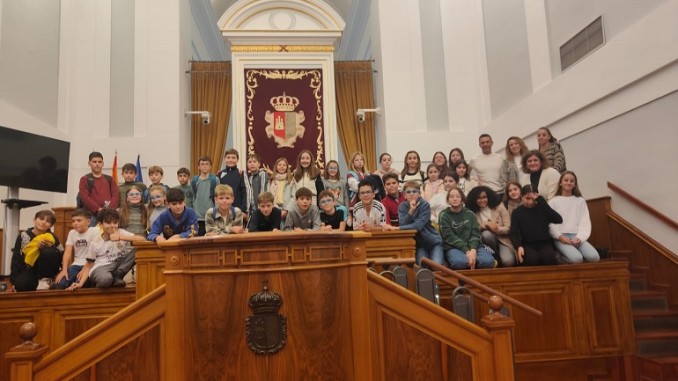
[367,271,514,381]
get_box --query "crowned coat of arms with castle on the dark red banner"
[264,92,306,148]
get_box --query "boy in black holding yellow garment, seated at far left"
[9,209,64,292]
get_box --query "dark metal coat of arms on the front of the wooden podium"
[245,281,287,355]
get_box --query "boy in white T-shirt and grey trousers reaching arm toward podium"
[87,209,145,290]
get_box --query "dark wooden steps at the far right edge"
[629,262,678,381]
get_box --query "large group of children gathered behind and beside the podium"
[5,137,599,291]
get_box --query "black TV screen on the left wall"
[0,126,71,193]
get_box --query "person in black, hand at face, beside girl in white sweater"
[510,185,563,266]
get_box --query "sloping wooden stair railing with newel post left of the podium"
[6,286,166,381]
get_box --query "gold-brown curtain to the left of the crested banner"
[191,61,232,175]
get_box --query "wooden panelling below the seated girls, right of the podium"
[440,261,635,363]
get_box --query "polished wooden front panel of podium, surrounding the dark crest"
[186,268,354,381]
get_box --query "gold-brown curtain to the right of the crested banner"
[334,61,377,171]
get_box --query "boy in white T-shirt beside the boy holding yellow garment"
[54,208,101,290]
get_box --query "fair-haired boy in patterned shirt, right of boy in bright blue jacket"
[205,184,245,236]
